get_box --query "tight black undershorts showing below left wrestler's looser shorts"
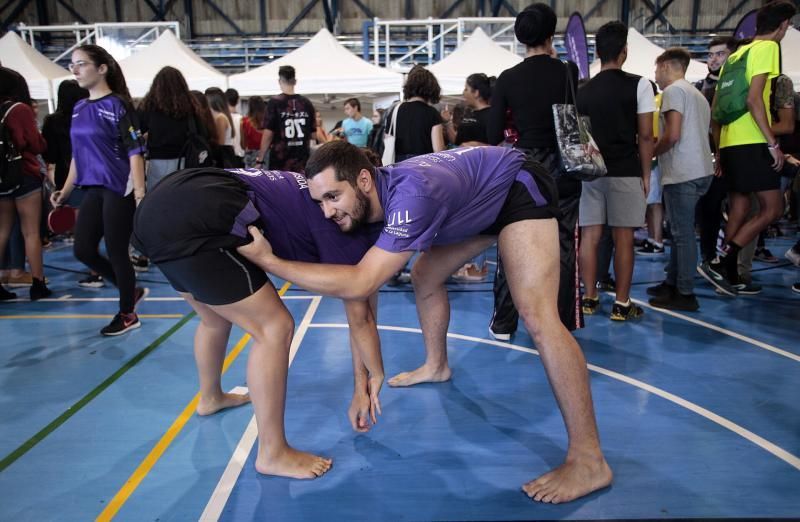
[157,248,272,305]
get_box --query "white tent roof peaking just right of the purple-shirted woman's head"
[54,31,228,98]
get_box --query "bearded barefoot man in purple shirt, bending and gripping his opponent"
[238,142,612,503]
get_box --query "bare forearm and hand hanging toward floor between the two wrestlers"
[344,293,384,432]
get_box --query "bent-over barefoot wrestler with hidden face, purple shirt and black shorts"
[132,168,384,478]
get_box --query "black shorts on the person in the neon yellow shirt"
[719,143,781,194]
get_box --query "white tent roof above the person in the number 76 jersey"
[229,29,403,96]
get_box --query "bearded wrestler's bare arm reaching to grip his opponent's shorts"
[237,226,414,299]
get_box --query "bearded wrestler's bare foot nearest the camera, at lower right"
[522,452,614,504]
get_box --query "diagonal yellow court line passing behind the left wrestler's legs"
[96,282,291,522]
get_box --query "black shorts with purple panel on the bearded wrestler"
[481,159,561,236]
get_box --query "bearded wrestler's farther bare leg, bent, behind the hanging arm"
[389,236,495,386]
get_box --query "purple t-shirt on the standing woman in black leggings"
[70,94,145,196]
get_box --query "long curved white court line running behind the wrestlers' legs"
[309,323,800,470]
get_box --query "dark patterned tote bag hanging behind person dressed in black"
[553,60,608,181]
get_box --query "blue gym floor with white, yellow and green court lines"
[0,238,800,521]
